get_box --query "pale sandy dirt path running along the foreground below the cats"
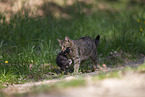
[2,58,145,97]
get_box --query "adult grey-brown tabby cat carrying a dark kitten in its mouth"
[58,35,101,73]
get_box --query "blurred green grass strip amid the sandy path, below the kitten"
[15,79,86,96]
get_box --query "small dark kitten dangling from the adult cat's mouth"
[56,47,72,73]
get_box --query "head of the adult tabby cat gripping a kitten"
[57,36,73,51]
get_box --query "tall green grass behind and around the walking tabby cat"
[0,0,145,88]
